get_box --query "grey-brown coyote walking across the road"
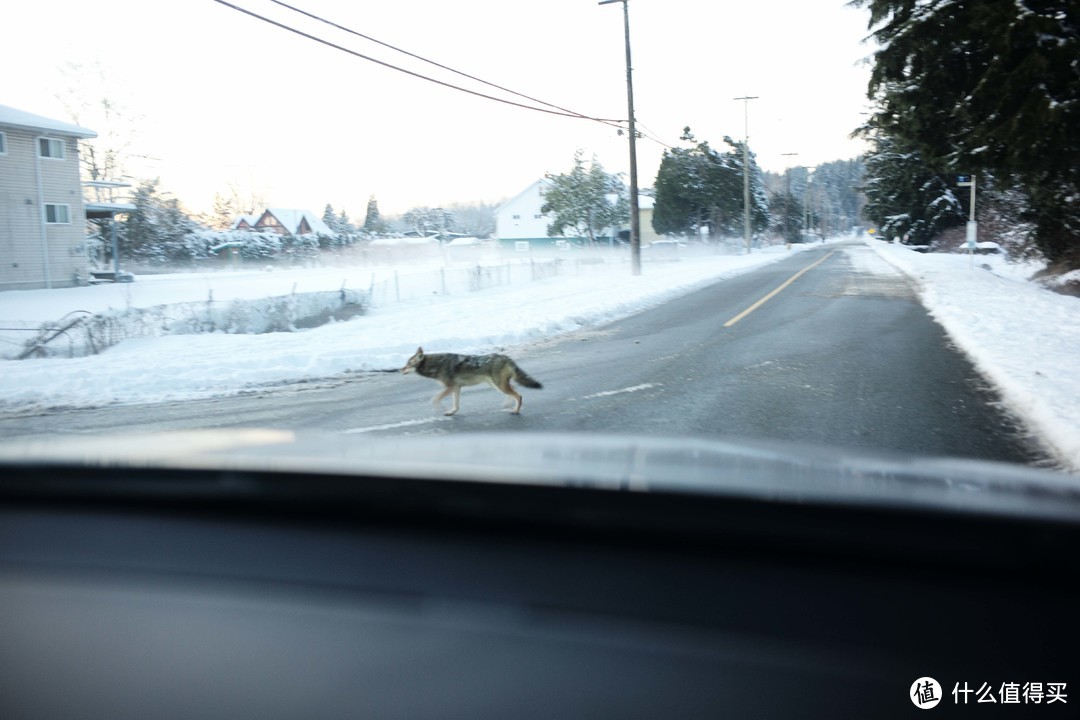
[402,348,543,416]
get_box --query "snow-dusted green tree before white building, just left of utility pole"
[540,150,630,245]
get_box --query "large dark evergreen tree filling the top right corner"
[851,0,1080,268]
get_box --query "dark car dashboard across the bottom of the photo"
[0,431,1080,720]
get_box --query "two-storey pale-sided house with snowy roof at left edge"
[0,105,97,290]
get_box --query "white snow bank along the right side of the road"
[868,241,1080,472]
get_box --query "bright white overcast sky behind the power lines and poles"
[0,0,872,221]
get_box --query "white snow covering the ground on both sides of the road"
[0,241,1080,472]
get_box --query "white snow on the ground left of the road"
[0,246,807,411]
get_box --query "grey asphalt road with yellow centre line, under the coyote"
[0,244,1040,463]
